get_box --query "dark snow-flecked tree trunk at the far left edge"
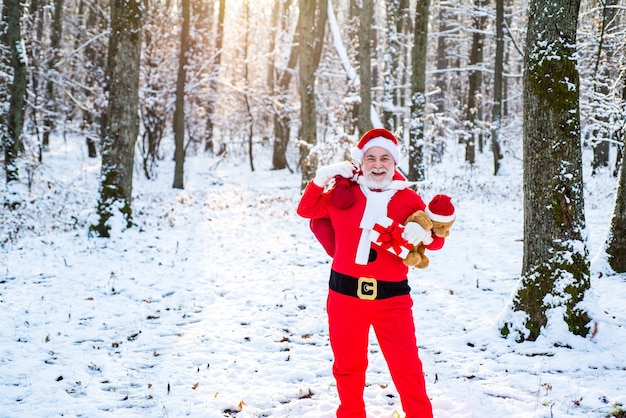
[0,0,27,192]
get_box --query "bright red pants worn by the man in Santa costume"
[326,290,433,418]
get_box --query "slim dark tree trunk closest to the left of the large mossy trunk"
[491,0,504,176]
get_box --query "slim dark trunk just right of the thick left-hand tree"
[172,0,191,189]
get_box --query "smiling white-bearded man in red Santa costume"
[298,128,444,418]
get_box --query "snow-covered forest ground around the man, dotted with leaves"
[0,137,626,418]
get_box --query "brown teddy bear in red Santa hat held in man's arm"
[404,194,456,268]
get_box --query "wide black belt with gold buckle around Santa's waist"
[328,270,411,300]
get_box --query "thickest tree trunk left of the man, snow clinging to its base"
[91,0,143,237]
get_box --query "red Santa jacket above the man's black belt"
[297,178,444,282]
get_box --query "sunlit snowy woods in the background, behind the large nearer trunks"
[0,0,626,187]
